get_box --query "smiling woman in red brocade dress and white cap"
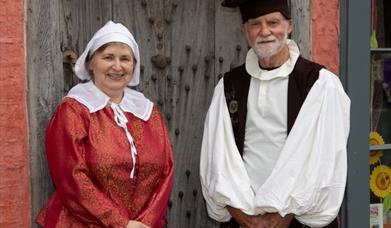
[37,21,173,228]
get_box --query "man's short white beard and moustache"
[250,26,288,59]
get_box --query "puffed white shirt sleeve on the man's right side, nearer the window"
[255,69,350,227]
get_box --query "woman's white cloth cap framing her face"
[75,21,140,86]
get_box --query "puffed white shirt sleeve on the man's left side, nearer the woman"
[200,79,254,222]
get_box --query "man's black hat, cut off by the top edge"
[221,0,291,23]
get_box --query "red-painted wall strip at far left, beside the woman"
[0,0,31,227]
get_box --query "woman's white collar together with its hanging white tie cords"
[66,81,153,178]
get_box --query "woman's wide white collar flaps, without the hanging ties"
[67,81,153,121]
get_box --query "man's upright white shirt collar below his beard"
[246,39,300,80]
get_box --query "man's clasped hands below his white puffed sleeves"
[227,206,294,228]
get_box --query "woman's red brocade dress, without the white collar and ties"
[36,84,173,228]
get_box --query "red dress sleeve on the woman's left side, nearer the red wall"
[46,100,129,228]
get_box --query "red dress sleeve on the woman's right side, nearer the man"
[136,110,174,227]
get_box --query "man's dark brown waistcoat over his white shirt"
[221,57,338,228]
